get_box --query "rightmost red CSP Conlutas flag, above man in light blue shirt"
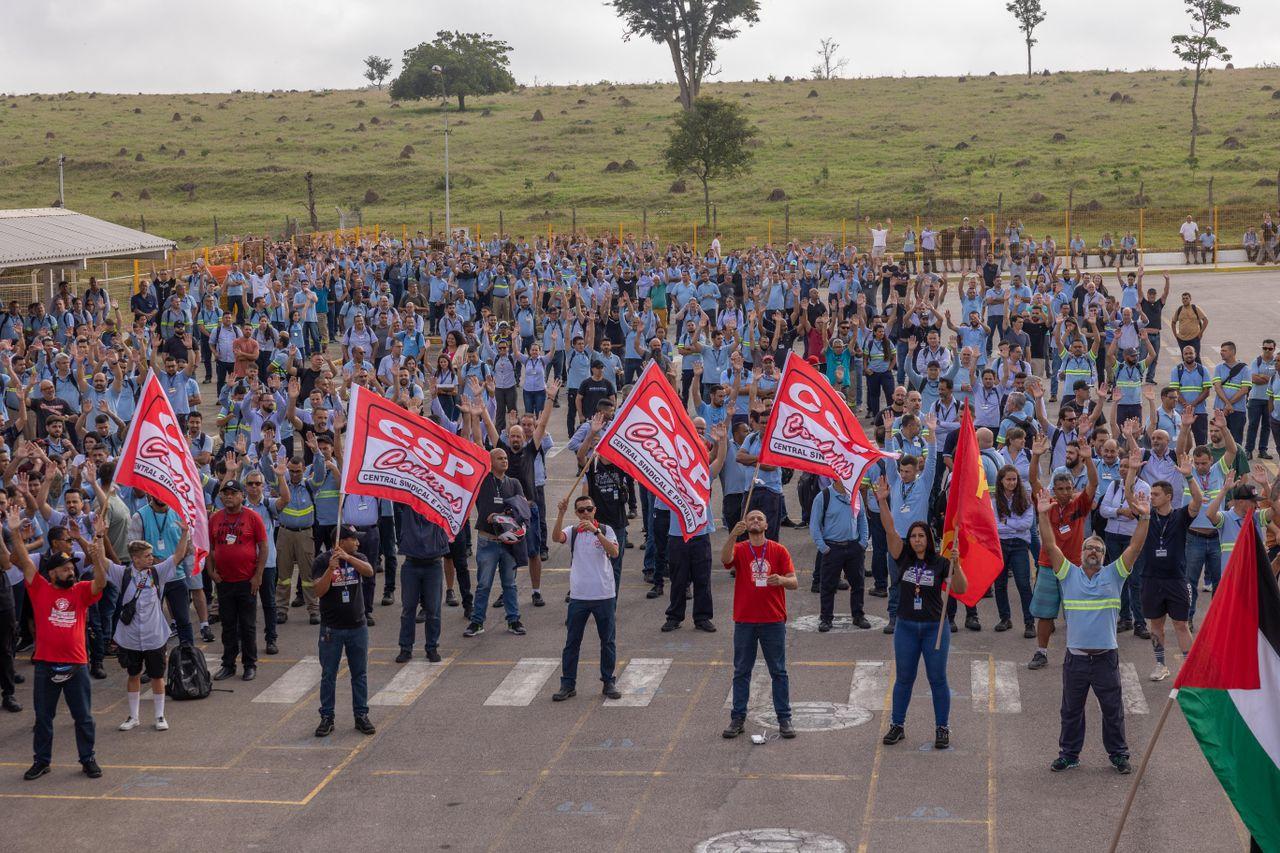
[759,352,893,507]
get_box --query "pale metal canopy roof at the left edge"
[0,207,177,269]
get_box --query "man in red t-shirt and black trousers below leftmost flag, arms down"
[205,480,266,681]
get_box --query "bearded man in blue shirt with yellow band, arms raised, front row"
[1036,489,1152,774]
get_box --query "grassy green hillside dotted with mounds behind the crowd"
[0,69,1280,246]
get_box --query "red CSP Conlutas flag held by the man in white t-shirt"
[595,361,712,539]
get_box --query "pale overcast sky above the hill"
[0,0,1280,92]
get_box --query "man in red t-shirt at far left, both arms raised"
[0,503,106,781]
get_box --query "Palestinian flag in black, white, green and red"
[1174,514,1280,850]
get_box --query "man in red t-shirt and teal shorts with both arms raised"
[1027,435,1098,670]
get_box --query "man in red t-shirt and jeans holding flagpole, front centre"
[721,510,799,738]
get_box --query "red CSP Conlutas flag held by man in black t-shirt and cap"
[342,386,489,542]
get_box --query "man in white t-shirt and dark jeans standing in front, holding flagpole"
[552,494,622,702]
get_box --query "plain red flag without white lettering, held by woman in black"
[942,406,1005,607]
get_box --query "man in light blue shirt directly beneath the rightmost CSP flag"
[809,480,872,634]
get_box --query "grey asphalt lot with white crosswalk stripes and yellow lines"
[0,267,1280,852]
